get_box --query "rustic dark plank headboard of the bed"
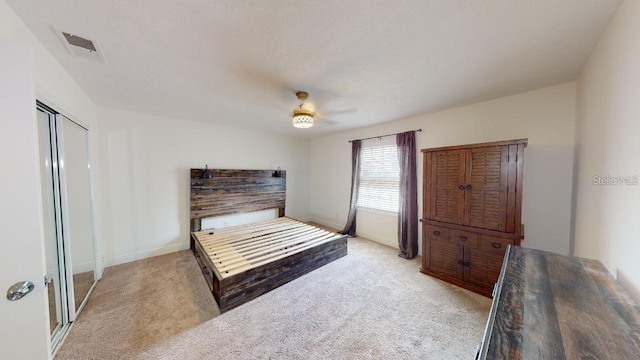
[190,169,287,247]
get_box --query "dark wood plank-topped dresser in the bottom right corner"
[477,246,640,360]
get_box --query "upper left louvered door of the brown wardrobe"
[424,150,465,224]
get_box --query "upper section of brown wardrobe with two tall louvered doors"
[422,139,526,233]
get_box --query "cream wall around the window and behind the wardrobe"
[311,82,575,254]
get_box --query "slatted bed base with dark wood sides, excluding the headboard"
[192,218,347,312]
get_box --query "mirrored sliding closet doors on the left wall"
[37,102,96,349]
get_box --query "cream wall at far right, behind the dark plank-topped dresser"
[574,0,640,304]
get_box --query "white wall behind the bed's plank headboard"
[99,108,309,265]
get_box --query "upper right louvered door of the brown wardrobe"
[464,146,508,231]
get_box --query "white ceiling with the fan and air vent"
[7,0,620,138]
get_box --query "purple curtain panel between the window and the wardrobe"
[398,131,418,259]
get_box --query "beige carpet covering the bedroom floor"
[56,238,491,360]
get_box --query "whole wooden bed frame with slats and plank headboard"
[190,169,347,313]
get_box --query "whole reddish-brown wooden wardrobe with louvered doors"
[420,139,527,297]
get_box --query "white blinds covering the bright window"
[358,144,400,212]
